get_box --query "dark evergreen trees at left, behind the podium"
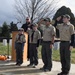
[0,22,18,38]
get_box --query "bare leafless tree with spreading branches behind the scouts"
[15,0,60,22]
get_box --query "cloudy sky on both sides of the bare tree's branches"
[0,0,75,26]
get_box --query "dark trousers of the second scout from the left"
[29,43,38,65]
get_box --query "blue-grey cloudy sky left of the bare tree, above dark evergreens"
[0,0,15,26]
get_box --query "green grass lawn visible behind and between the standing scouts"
[0,43,75,64]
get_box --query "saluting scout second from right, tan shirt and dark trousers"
[40,18,56,72]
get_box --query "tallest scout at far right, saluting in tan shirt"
[56,14,74,75]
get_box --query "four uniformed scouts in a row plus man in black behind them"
[15,14,74,75]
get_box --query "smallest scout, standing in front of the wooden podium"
[15,28,26,66]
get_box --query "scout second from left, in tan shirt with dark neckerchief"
[27,23,41,68]
